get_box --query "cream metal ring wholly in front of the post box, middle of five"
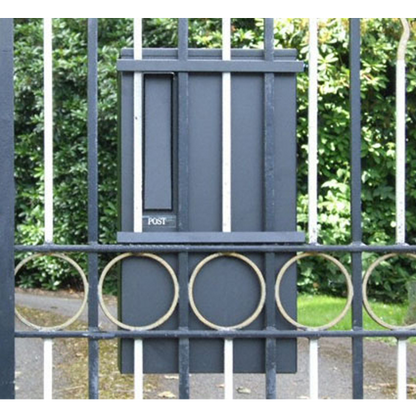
[189,253,266,331]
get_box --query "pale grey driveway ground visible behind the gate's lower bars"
[16,293,416,402]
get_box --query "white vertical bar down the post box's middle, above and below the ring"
[222,15,234,403]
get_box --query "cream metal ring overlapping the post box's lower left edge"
[98,253,179,332]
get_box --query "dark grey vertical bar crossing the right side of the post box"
[264,15,277,403]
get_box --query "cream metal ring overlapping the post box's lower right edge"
[276,253,354,331]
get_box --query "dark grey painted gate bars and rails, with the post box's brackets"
[0,15,416,402]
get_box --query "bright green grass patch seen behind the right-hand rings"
[298,295,408,331]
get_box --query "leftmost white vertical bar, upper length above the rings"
[43,15,54,244]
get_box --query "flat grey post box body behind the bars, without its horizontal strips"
[120,50,298,373]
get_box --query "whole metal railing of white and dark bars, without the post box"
[0,15,416,402]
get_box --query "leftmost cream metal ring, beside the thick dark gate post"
[15,254,89,332]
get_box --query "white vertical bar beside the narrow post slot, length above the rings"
[134,15,143,233]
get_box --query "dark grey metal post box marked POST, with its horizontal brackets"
[118,49,305,374]
